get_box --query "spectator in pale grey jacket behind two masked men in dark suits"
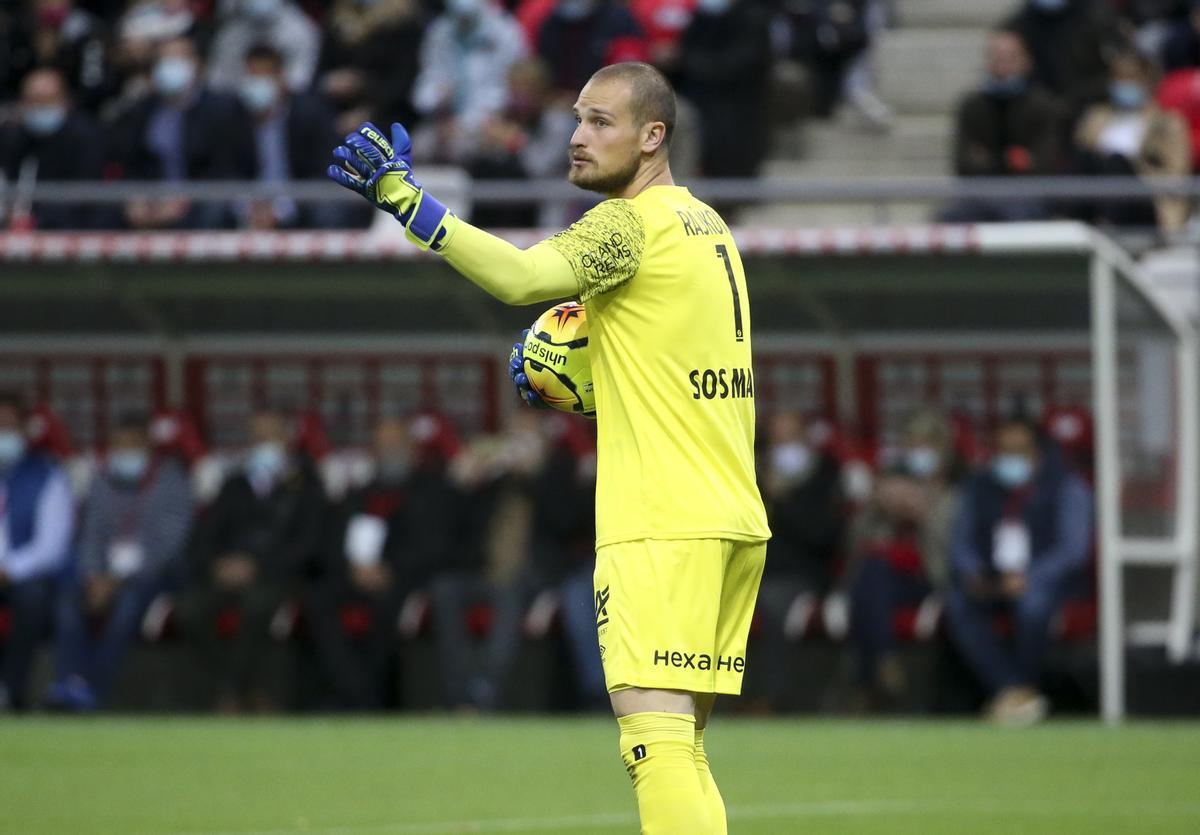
[209,0,320,92]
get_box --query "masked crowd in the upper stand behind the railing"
[0,0,1200,232]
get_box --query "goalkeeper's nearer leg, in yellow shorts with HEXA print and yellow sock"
[595,541,724,835]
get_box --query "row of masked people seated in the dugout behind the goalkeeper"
[0,383,1093,721]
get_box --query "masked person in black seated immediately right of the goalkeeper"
[758,413,846,708]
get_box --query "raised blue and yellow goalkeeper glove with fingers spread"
[326,122,454,252]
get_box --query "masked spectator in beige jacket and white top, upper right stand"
[1075,50,1192,234]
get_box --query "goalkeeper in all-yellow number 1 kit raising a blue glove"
[329,64,770,835]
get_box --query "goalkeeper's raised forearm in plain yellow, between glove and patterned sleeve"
[442,220,580,305]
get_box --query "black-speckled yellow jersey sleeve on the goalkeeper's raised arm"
[538,199,646,301]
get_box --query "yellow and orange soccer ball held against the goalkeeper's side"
[524,301,596,418]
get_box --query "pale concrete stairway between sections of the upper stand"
[742,0,1020,226]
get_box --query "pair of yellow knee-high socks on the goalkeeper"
[617,713,710,835]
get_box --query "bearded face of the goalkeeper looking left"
[566,80,642,194]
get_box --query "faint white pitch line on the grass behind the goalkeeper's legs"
[175,800,922,835]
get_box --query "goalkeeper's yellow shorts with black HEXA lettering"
[595,540,767,696]
